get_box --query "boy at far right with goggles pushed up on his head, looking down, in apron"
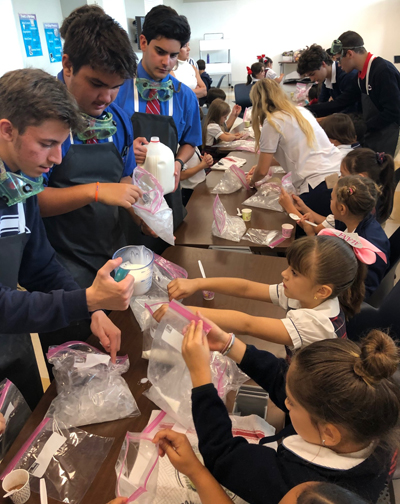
[331,31,400,157]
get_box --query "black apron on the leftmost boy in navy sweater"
[0,203,43,410]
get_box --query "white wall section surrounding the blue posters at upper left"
[11,0,63,75]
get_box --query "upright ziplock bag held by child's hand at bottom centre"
[115,412,166,504]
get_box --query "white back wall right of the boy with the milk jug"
[141,0,400,83]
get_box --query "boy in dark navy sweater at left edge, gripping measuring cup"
[0,69,133,408]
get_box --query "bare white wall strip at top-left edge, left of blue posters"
[0,0,23,76]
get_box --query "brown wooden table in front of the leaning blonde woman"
[175,151,295,251]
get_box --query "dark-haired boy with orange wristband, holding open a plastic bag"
[38,13,140,287]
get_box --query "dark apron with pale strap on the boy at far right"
[358,56,400,157]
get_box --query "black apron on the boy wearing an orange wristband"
[43,139,126,288]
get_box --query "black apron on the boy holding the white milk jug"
[121,86,187,254]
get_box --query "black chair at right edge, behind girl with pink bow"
[346,282,400,341]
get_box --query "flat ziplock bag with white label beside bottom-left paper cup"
[1,418,114,504]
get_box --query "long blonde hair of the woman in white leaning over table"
[250,79,315,151]
